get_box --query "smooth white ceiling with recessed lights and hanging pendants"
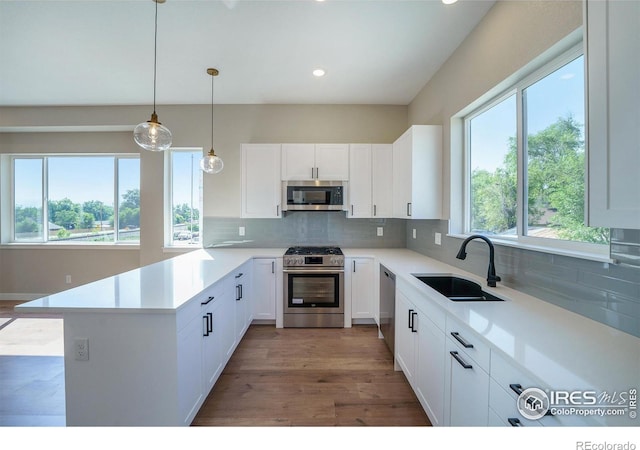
[0,0,494,106]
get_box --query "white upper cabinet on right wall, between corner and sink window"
[392,125,442,219]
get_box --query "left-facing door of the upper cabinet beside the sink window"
[392,129,412,219]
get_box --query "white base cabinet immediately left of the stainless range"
[251,258,282,320]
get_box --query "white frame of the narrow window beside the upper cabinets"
[164,147,204,251]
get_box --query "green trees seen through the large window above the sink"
[471,116,609,244]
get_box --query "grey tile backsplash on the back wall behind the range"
[203,211,406,248]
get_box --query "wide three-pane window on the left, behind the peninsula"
[12,155,140,244]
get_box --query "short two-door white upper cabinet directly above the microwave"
[282,144,349,181]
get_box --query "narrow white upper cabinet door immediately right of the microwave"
[347,144,372,218]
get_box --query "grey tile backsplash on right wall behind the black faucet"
[406,220,640,337]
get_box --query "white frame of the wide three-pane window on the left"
[2,153,140,248]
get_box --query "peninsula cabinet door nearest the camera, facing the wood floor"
[177,314,203,425]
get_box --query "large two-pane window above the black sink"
[464,49,609,253]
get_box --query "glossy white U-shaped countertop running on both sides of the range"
[16,248,640,408]
